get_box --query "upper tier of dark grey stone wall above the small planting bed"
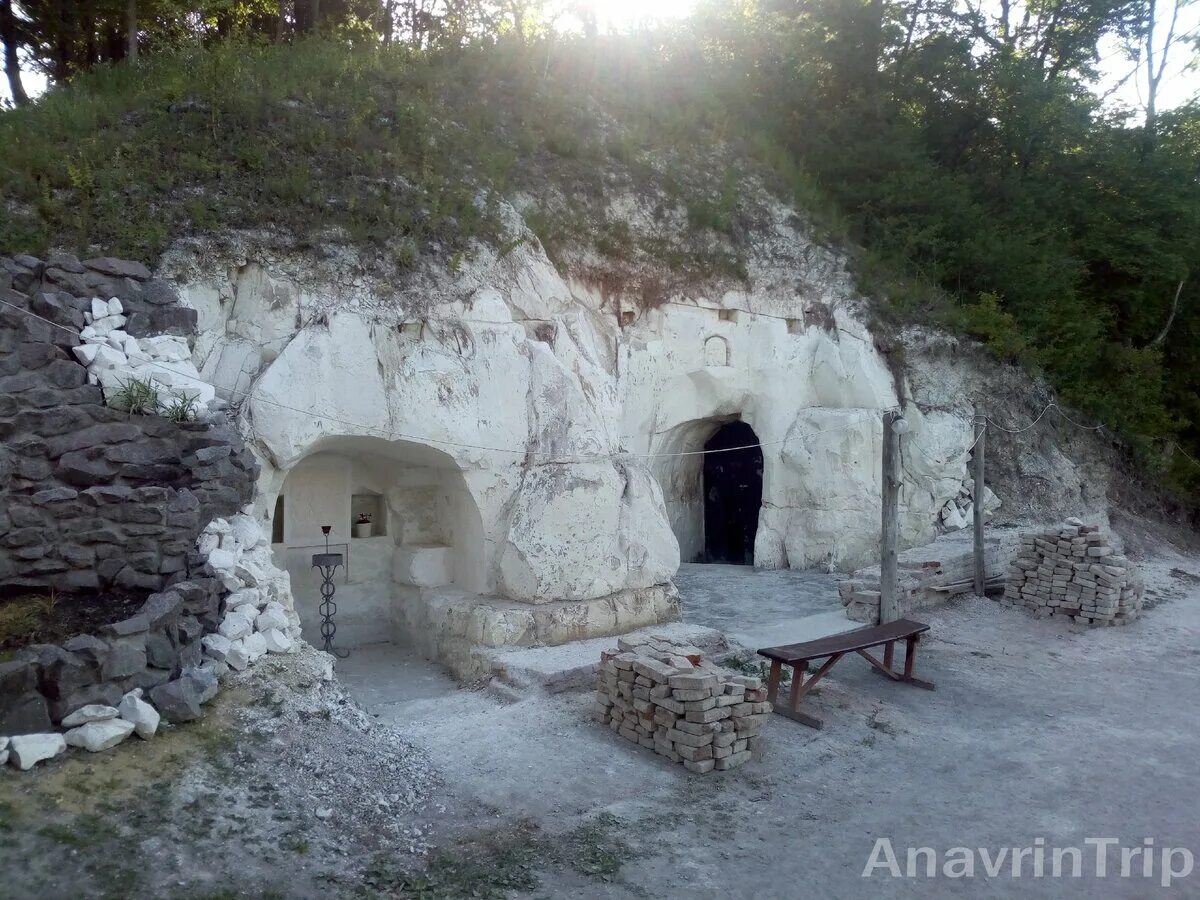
[0,256,257,593]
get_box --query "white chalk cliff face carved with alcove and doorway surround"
[164,194,971,672]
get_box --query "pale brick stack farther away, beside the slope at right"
[1001,518,1142,625]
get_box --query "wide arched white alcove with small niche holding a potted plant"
[272,437,484,647]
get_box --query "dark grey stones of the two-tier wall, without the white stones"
[0,256,265,736]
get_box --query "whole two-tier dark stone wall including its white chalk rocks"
[0,256,299,769]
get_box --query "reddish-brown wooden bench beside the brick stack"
[758,619,934,728]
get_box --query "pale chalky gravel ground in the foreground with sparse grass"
[0,520,1200,898]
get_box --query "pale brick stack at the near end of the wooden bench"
[595,635,770,774]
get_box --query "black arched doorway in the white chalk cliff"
[704,421,762,565]
